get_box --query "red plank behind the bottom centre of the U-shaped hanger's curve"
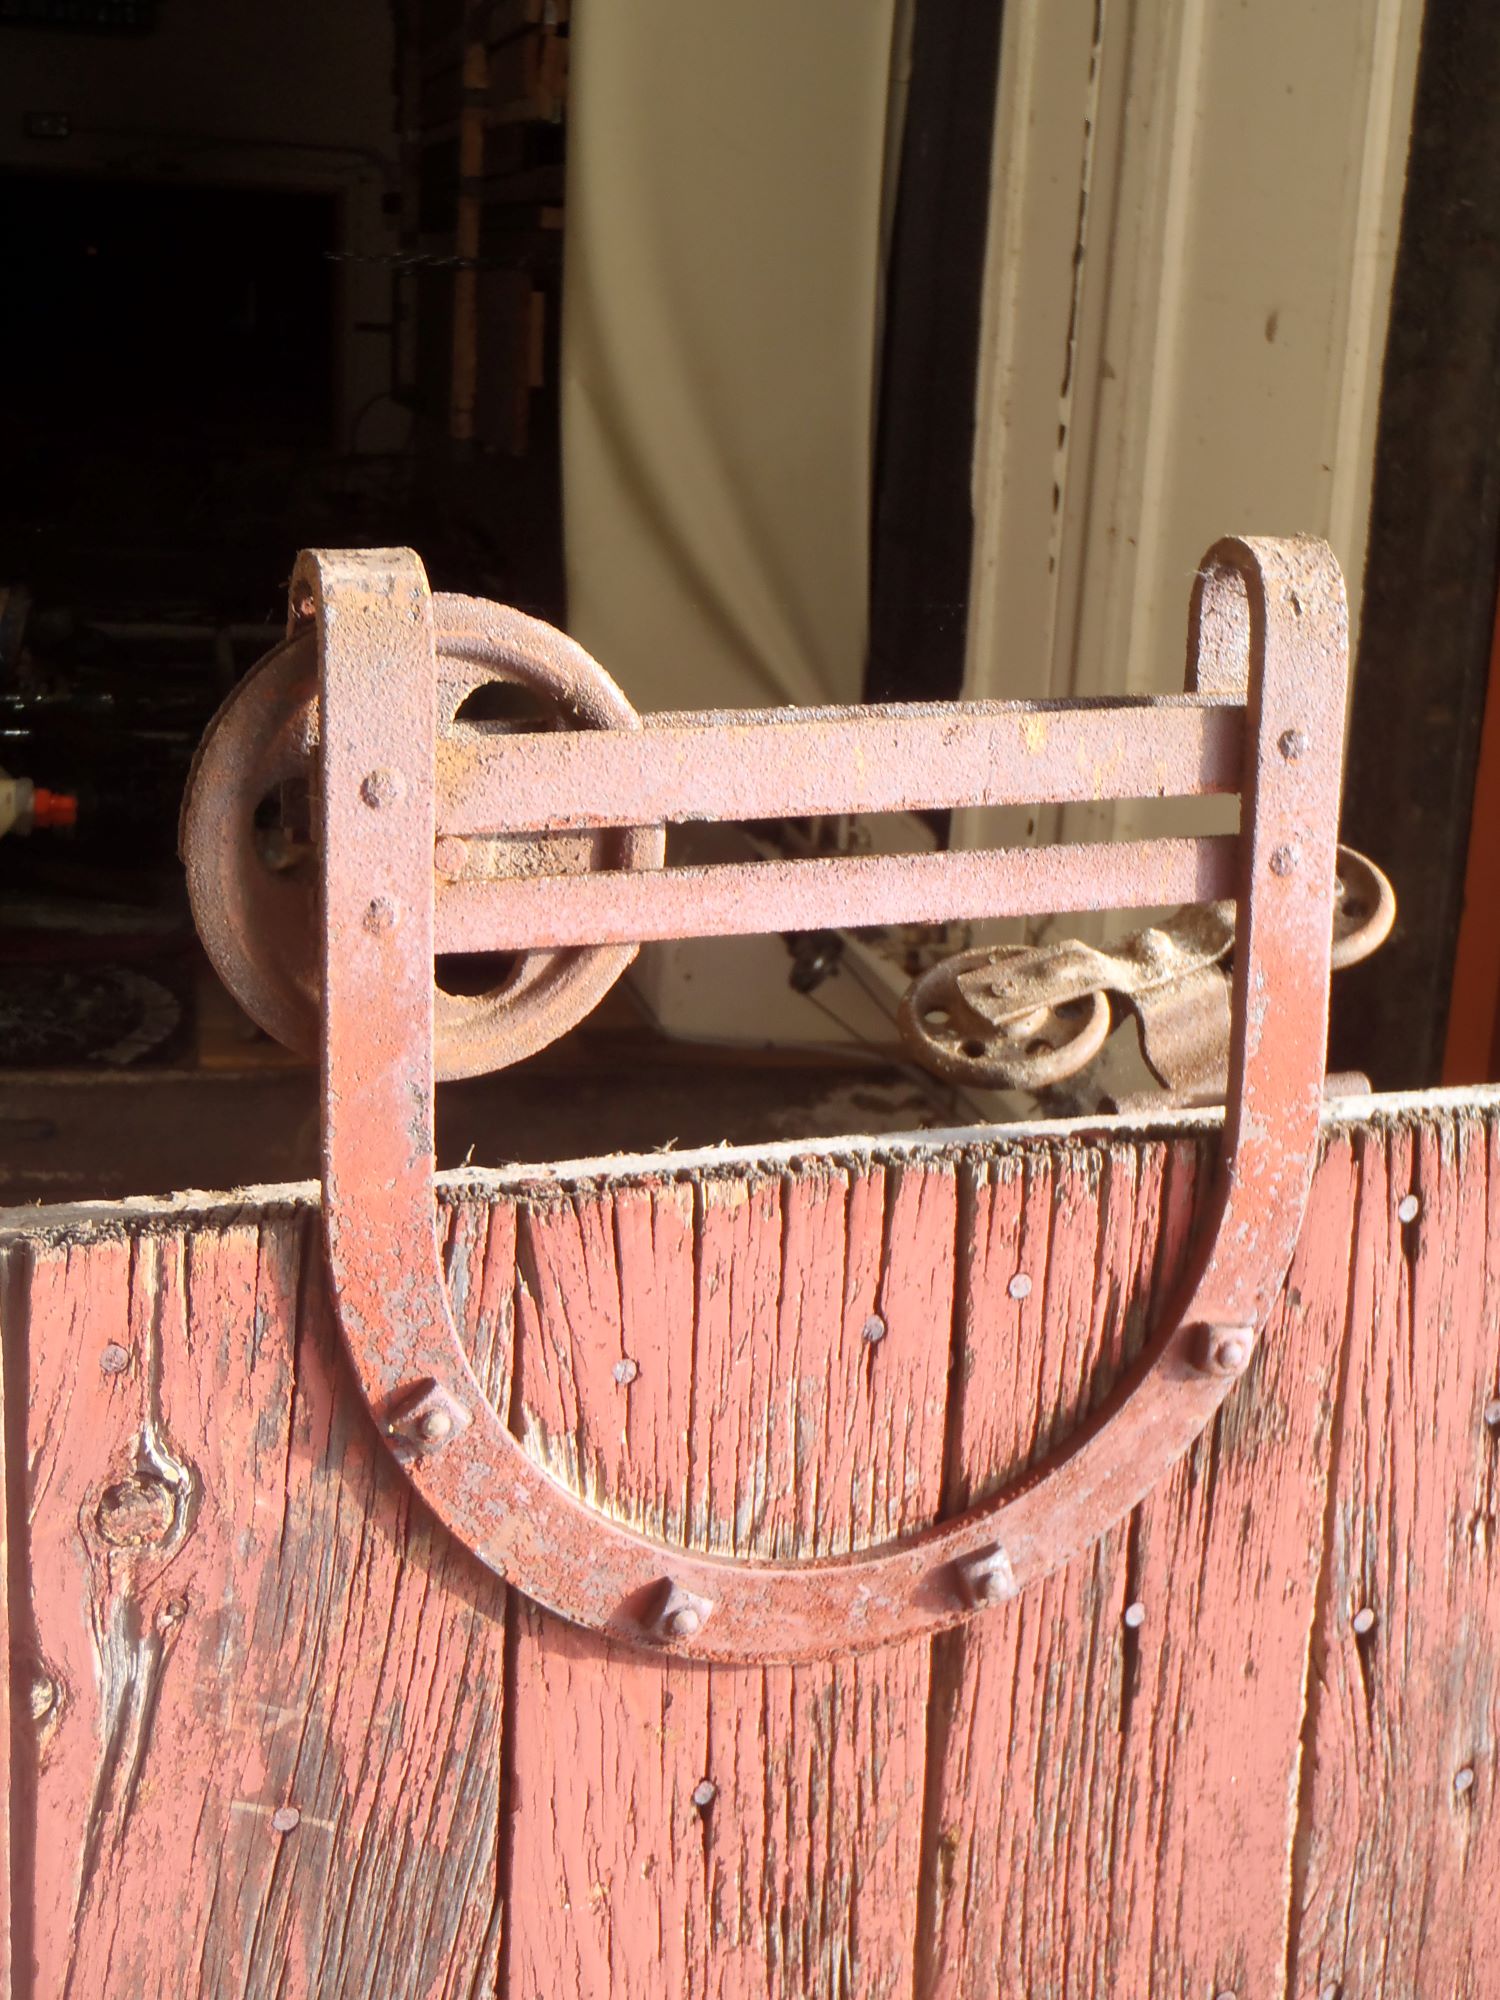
[508,1168,954,2000]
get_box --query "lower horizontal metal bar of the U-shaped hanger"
[436,834,1238,952]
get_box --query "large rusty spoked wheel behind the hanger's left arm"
[180,596,664,1078]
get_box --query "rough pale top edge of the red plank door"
[0,1084,1500,1248]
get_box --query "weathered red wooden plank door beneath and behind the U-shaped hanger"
[4,1096,1500,2000]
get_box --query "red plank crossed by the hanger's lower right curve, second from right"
[918,1146,1350,2000]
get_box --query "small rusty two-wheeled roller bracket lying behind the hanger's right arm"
[896,848,1396,1108]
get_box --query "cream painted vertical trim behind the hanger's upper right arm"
[960,0,1422,772]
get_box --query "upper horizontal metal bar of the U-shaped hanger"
[438,696,1246,834]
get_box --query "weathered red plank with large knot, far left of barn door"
[17,1220,504,2000]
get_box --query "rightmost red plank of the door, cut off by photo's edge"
[1292,1114,1500,2000]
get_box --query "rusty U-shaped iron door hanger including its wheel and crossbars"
[182,540,1348,1660]
